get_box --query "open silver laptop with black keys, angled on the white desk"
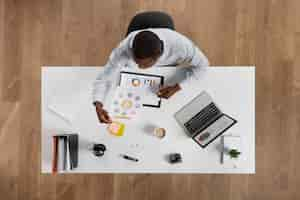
[175,91,237,148]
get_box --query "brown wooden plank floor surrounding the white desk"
[0,0,300,200]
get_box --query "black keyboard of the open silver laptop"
[184,103,221,134]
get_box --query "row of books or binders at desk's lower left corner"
[52,134,78,173]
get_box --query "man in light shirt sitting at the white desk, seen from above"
[93,28,209,123]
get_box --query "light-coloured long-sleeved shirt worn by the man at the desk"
[93,28,209,102]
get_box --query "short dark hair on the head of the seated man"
[132,31,163,59]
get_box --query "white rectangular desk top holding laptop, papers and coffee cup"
[41,67,255,173]
